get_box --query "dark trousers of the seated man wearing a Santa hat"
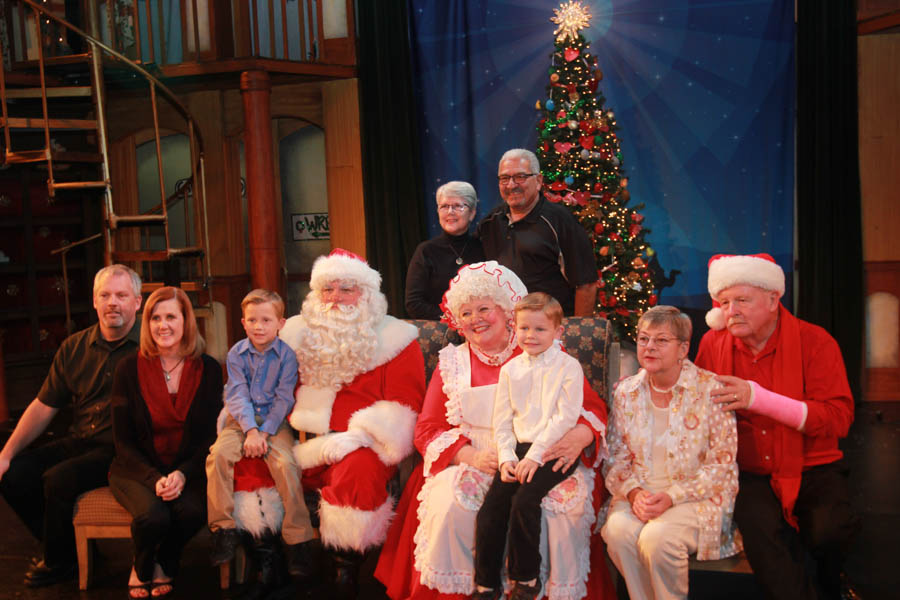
[734,461,858,600]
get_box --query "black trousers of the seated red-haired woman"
[109,475,206,581]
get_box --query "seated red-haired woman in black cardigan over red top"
[109,287,222,598]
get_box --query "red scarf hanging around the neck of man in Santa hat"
[709,305,804,529]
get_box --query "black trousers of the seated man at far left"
[0,437,114,567]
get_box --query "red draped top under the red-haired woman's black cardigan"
[138,353,203,466]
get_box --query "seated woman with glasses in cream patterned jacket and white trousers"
[601,306,741,600]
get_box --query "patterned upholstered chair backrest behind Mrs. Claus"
[409,317,612,401]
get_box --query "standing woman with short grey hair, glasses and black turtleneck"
[406,181,484,320]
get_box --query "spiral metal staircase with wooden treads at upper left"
[0,0,210,324]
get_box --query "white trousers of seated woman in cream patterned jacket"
[600,500,699,600]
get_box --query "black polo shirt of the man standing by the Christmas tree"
[477,196,597,315]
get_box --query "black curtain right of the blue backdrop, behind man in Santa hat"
[797,0,864,401]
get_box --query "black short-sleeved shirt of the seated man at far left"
[38,320,141,443]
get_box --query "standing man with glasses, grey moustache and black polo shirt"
[478,148,598,316]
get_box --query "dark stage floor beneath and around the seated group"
[0,402,900,600]
